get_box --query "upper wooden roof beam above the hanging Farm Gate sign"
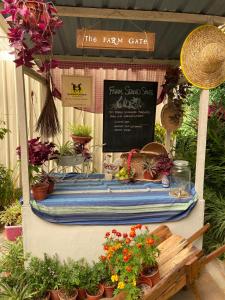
[56,6,225,25]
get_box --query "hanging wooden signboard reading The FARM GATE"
[77,29,155,51]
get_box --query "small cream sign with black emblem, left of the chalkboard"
[62,75,92,109]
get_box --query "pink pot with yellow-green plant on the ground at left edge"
[0,201,22,241]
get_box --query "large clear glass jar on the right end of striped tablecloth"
[170,160,191,198]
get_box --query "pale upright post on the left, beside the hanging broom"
[16,67,30,206]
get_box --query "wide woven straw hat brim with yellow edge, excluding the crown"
[180,25,225,90]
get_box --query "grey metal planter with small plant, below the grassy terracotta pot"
[57,141,84,166]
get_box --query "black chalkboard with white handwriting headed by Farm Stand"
[103,80,158,152]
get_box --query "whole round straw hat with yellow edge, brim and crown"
[180,25,225,90]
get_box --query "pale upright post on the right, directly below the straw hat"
[195,90,209,199]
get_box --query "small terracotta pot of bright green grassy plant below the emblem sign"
[69,124,92,145]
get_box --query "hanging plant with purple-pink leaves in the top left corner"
[2,0,62,72]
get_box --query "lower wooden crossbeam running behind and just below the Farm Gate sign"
[36,55,180,66]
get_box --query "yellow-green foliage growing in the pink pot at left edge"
[0,201,22,226]
